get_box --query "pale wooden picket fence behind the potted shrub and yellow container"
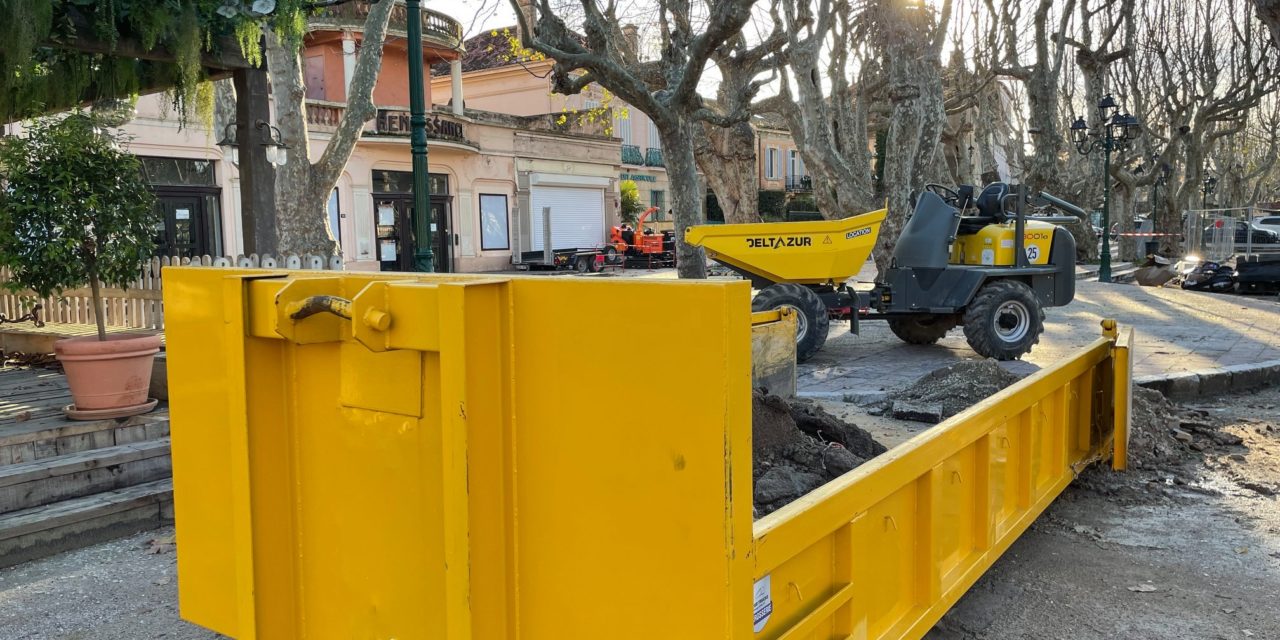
[0,253,342,330]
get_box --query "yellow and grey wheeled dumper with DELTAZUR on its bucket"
[685,183,1083,361]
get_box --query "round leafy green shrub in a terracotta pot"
[0,113,160,419]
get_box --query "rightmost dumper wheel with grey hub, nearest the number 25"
[964,280,1044,360]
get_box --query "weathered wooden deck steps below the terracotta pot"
[0,367,173,567]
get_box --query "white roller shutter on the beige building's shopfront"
[529,187,604,251]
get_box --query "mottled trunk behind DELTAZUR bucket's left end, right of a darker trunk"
[694,122,760,224]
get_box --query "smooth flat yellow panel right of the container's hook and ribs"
[513,279,751,640]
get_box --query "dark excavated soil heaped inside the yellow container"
[751,393,887,517]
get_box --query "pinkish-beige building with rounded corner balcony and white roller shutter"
[94,3,622,271]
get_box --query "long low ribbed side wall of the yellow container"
[742,320,1132,640]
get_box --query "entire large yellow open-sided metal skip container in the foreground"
[165,268,1128,640]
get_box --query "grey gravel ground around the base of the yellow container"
[0,388,1280,640]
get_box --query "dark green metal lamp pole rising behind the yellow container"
[409,0,435,273]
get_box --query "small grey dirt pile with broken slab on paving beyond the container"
[887,360,1019,424]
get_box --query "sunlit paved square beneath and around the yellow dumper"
[797,282,1280,397]
